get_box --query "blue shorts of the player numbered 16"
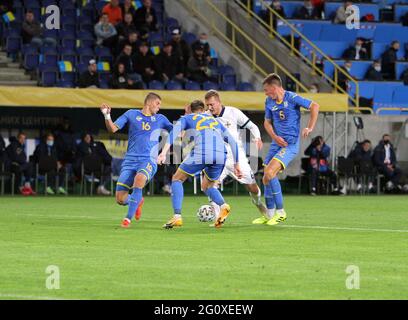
[116,158,157,191]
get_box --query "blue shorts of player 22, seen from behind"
[178,155,225,181]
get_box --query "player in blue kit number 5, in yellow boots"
[252,73,319,226]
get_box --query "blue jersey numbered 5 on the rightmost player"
[265,91,312,144]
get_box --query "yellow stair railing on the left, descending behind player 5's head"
[181,0,309,92]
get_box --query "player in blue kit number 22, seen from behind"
[157,100,242,229]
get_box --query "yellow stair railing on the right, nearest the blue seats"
[235,0,362,112]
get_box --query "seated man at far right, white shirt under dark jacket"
[374,134,402,191]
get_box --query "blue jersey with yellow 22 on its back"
[168,113,238,162]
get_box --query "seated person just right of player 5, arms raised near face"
[305,136,343,196]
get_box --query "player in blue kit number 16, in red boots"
[101,92,173,228]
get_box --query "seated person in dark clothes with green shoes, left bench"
[32,133,67,194]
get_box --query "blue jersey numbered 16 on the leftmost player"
[115,110,173,161]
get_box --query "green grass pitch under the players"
[0,196,408,299]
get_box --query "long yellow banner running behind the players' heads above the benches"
[0,87,348,112]
